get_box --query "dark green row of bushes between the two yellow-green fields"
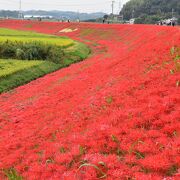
[0,40,65,63]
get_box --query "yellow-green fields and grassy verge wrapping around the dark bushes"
[0,28,90,93]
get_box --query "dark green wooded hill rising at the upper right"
[121,0,180,24]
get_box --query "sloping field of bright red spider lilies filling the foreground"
[0,20,180,180]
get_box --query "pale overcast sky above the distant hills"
[0,0,128,13]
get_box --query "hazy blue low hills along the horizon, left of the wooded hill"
[0,10,105,20]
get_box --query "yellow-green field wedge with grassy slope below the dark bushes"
[0,60,62,93]
